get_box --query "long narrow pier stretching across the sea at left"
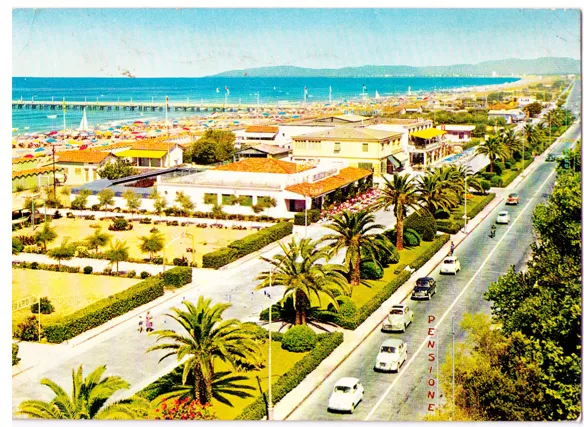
[12,100,305,112]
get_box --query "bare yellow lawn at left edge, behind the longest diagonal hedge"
[12,268,141,331]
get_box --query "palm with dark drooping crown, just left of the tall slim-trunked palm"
[320,211,388,286]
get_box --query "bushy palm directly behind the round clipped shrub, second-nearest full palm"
[256,238,349,325]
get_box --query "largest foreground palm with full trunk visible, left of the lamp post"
[148,296,262,404]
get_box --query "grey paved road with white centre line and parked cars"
[288,120,580,421]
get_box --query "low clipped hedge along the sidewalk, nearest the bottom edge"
[235,332,343,420]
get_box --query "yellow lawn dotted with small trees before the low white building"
[12,218,255,265]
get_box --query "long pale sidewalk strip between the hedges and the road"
[274,128,576,420]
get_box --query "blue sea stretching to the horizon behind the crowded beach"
[12,77,519,133]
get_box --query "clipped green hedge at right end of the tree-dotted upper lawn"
[203,222,294,269]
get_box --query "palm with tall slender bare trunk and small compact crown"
[372,174,421,251]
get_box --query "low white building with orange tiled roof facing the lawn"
[157,158,371,218]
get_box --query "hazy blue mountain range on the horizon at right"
[212,57,580,77]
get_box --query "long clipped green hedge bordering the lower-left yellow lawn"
[44,276,164,343]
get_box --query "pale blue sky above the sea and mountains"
[12,8,581,77]
